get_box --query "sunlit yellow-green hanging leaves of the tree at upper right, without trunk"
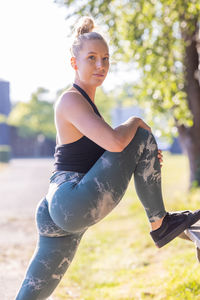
[55,0,200,131]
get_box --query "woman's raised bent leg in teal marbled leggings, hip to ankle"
[47,128,166,232]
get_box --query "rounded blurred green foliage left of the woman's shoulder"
[9,88,55,139]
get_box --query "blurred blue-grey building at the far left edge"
[0,80,11,145]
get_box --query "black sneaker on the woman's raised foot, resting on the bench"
[150,209,200,248]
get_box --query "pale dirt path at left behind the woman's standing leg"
[0,159,53,300]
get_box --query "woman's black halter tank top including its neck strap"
[54,83,105,173]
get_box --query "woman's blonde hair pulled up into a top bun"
[70,17,107,57]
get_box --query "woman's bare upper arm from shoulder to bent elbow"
[56,92,123,152]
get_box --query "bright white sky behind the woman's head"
[0,0,138,102]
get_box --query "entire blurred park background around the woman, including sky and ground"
[0,0,200,300]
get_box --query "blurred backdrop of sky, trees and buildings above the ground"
[0,0,200,185]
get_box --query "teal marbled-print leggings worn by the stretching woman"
[16,128,166,300]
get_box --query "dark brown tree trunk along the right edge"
[178,21,200,186]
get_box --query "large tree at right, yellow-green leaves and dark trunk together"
[55,0,200,186]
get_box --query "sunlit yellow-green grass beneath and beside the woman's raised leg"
[54,154,200,300]
